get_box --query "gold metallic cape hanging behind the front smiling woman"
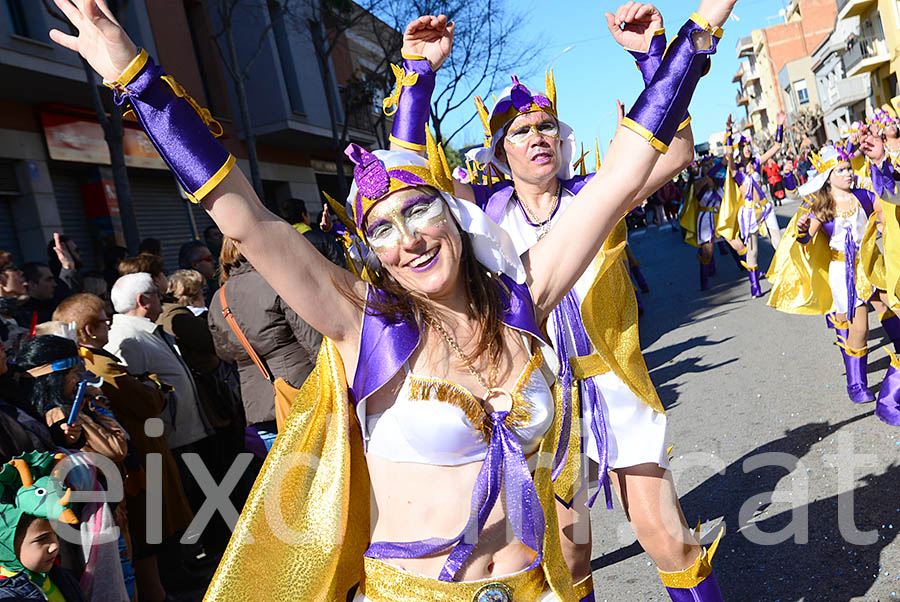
[203,338,576,602]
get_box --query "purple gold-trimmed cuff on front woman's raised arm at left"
[114,52,234,203]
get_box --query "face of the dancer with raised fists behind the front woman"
[500,111,562,182]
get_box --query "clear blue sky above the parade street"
[447,0,786,157]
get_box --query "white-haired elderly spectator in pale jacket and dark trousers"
[104,272,213,448]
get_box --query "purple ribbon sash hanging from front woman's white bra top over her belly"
[365,412,546,581]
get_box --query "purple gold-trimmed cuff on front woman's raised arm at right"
[622,13,721,153]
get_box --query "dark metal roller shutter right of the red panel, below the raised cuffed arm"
[128,173,193,273]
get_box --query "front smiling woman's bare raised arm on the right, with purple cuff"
[523,0,736,317]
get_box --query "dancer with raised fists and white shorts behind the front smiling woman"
[385,3,721,600]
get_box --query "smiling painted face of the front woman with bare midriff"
[364,187,462,298]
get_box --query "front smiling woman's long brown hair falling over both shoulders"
[338,220,508,365]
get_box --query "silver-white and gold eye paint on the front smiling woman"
[366,194,447,253]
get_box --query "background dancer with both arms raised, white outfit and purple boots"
[725,111,785,297]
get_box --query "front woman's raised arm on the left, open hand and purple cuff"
[50,0,365,346]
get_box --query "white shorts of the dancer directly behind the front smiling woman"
[581,371,669,469]
